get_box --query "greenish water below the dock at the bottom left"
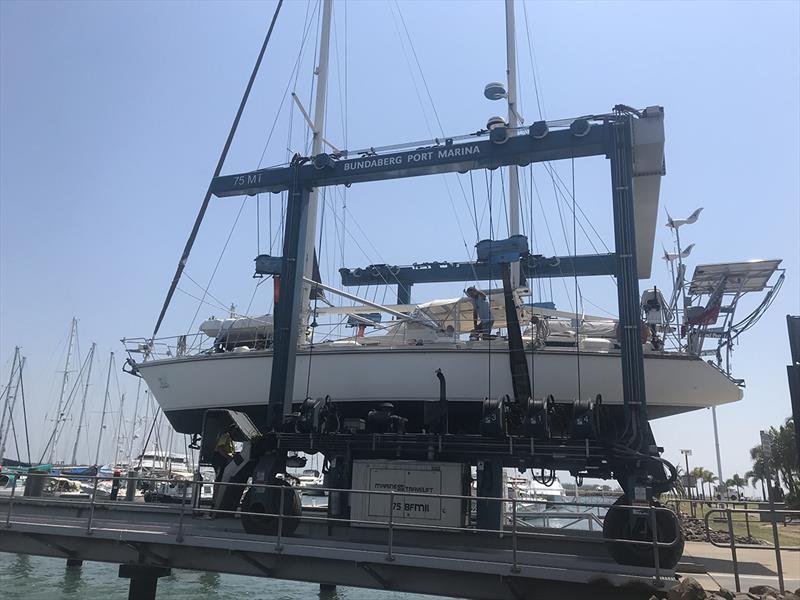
[0,552,456,600]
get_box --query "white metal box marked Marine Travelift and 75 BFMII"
[350,460,469,527]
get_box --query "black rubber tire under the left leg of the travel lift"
[242,479,302,535]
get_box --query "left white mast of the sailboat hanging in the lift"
[300,0,333,332]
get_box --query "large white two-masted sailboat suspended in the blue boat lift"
[126,0,776,433]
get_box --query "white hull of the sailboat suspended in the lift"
[138,345,742,432]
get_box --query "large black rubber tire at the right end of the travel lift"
[603,496,684,569]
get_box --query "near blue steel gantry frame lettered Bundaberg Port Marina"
[211,109,660,446]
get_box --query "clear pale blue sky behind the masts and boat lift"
[0,0,800,476]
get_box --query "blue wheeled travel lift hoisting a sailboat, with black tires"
[200,105,683,568]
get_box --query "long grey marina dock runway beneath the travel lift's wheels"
[0,490,675,600]
